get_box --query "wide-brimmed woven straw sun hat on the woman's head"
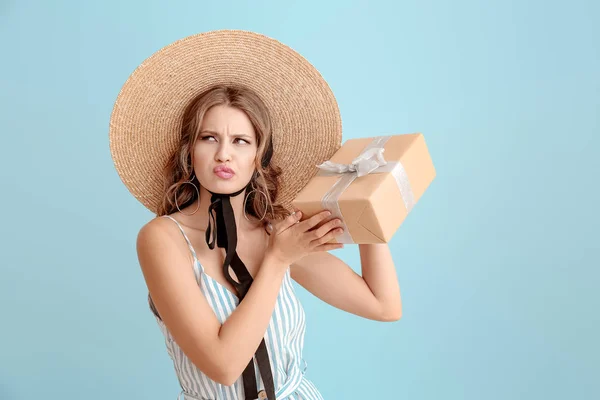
[109,30,342,213]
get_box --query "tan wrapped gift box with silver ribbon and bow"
[292,133,435,244]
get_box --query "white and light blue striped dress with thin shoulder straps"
[155,215,323,400]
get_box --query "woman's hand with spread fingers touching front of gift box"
[267,210,343,266]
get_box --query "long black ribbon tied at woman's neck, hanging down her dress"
[206,187,275,400]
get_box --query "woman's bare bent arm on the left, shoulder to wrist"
[137,218,286,385]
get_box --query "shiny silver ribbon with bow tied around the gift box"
[317,136,415,244]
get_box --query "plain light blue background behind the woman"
[0,0,600,400]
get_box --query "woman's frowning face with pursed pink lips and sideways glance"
[193,105,257,193]
